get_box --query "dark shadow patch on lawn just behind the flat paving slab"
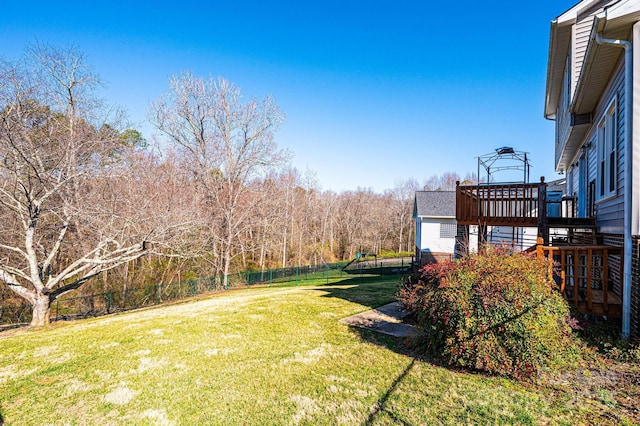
[314,275,400,309]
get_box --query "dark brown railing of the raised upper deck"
[456,182,546,227]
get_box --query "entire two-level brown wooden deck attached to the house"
[456,178,623,317]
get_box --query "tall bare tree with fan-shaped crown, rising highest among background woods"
[150,73,288,286]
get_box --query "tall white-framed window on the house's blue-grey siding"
[597,101,618,199]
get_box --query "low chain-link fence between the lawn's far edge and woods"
[0,262,346,326]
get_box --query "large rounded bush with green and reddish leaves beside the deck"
[398,247,581,378]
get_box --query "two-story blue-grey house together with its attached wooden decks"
[456,0,640,338]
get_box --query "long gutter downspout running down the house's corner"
[595,25,633,340]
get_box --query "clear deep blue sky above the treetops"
[0,0,575,192]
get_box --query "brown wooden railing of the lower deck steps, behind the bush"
[536,239,623,317]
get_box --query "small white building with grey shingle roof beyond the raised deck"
[413,191,476,266]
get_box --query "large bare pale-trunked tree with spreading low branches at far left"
[0,46,147,326]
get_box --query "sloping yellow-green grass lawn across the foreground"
[0,277,640,425]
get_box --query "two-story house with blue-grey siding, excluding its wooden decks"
[544,0,640,337]
